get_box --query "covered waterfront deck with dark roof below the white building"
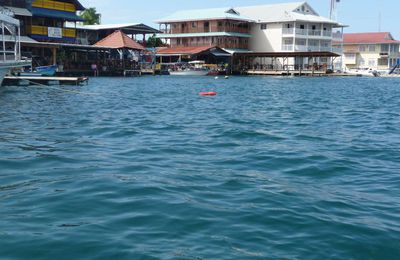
[231,52,340,76]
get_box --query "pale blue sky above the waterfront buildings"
[81,0,400,39]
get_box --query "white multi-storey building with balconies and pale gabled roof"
[236,2,343,53]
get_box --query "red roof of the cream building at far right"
[343,32,400,44]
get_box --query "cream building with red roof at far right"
[336,32,400,71]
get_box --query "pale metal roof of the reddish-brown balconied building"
[156,8,251,23]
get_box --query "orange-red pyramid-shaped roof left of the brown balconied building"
[95,31,145,50]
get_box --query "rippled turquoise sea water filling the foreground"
[0,76,400,259]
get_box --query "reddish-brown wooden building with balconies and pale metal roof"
[157,8,253,51]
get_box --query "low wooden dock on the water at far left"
[3,76,89,86]
